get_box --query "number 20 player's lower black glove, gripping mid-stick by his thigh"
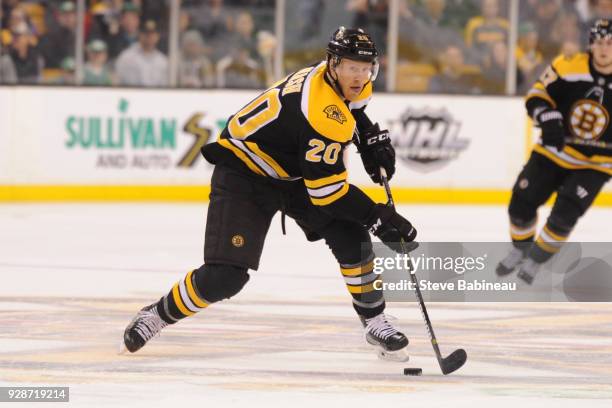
[367,204,416,253]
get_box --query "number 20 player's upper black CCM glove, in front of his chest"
[357,123,395,184]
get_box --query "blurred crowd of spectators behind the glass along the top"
[0,0,612,94]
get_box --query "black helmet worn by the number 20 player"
[327,26,378,63]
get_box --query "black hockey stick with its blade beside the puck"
[380,167,467,375]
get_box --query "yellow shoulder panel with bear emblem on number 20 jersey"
[301,62,355,143]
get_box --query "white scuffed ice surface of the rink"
[0,204,612,408]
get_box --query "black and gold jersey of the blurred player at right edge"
[526,53,612,174]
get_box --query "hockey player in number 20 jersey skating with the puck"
[124,27,416,361]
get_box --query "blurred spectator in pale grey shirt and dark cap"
[116,20,168,87]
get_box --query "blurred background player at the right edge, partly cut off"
[497,20,612,284]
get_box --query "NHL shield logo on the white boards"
[389,108,470,171]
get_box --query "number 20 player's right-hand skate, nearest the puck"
[360,313,409,362]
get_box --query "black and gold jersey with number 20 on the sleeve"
[202,62,374,223]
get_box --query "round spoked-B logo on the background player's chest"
[570,99,610,140]
